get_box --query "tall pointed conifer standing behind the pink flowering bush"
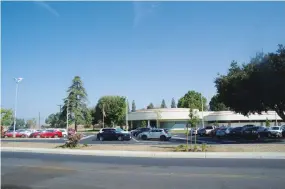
[61,76,88,131]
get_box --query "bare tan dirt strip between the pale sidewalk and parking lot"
[1,141,285,152]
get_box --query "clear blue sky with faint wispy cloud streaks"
[1,2,285,119]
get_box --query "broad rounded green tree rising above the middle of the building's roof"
[177,91,207,111]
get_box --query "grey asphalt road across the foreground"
[1,152,285,189]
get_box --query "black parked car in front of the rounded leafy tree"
[97,128,131,141]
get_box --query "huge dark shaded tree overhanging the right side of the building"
[215,45,285,120]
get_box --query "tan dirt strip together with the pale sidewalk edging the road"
[1,141,285,159]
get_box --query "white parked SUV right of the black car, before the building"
[138,129,172,141]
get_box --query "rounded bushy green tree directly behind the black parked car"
[94,96,126,126]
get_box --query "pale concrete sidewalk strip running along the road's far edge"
[1,147,285,159]
